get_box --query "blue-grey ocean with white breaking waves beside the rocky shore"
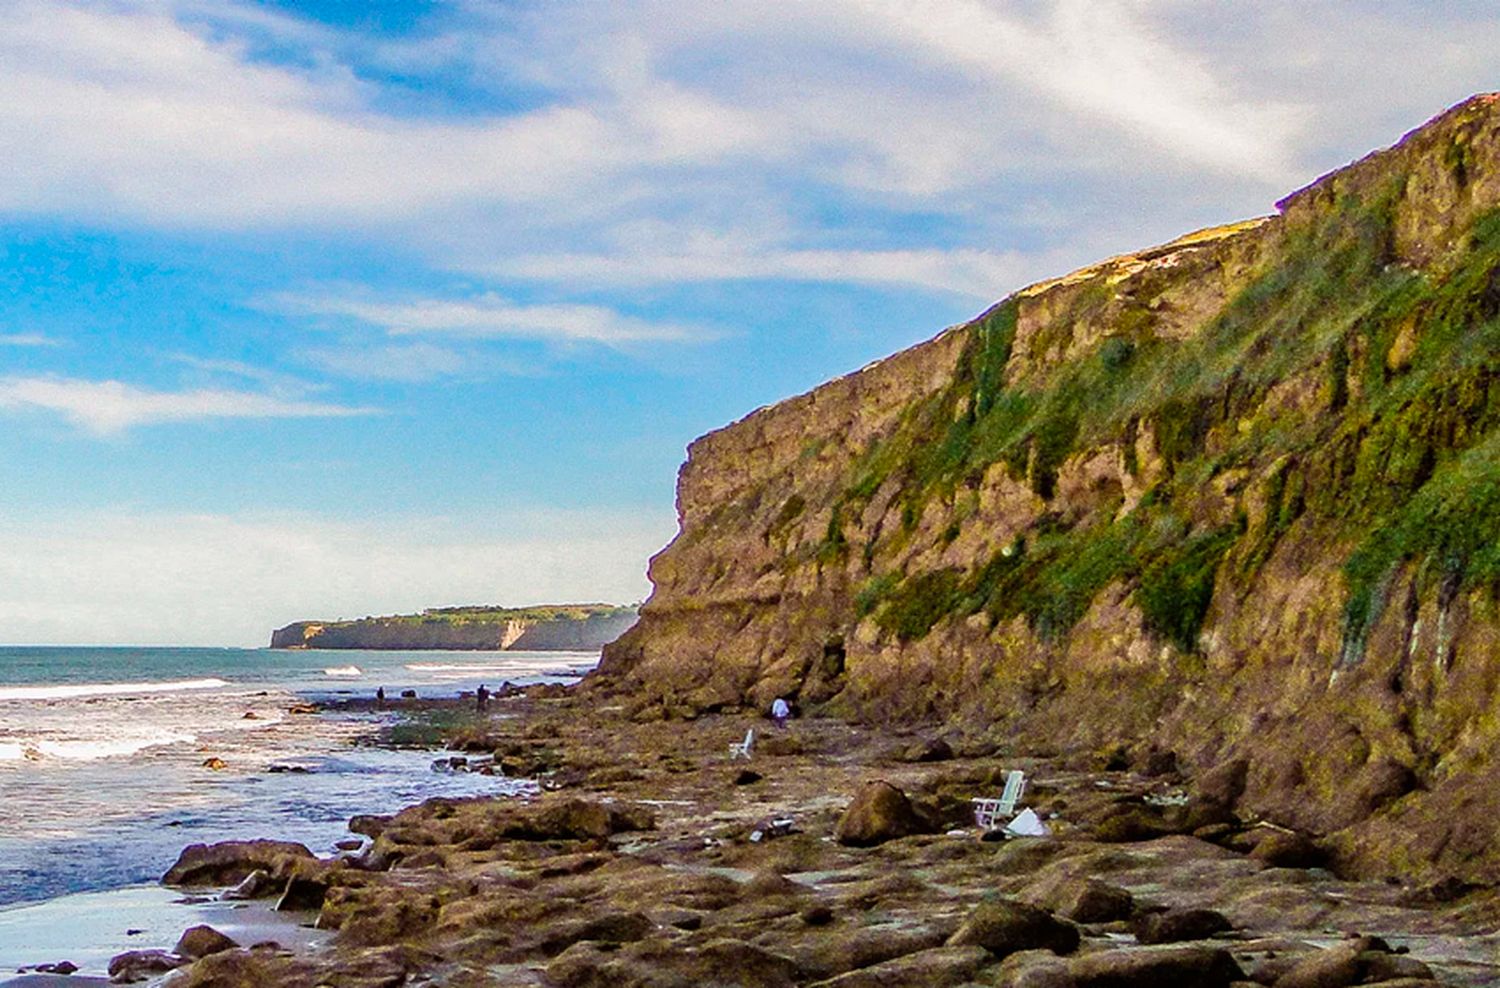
[0,648,599,917]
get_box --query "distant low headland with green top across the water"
[272,604,636,652]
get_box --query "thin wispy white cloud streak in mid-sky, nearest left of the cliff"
[269,292,710,345]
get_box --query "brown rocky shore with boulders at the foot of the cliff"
[20,687,1500,988]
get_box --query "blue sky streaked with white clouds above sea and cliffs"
[0,0,1500,646]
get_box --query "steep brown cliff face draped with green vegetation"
[596,96,1500,879]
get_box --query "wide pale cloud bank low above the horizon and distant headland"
[0,511,675,646]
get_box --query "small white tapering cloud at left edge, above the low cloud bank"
[0,378,372,435]
